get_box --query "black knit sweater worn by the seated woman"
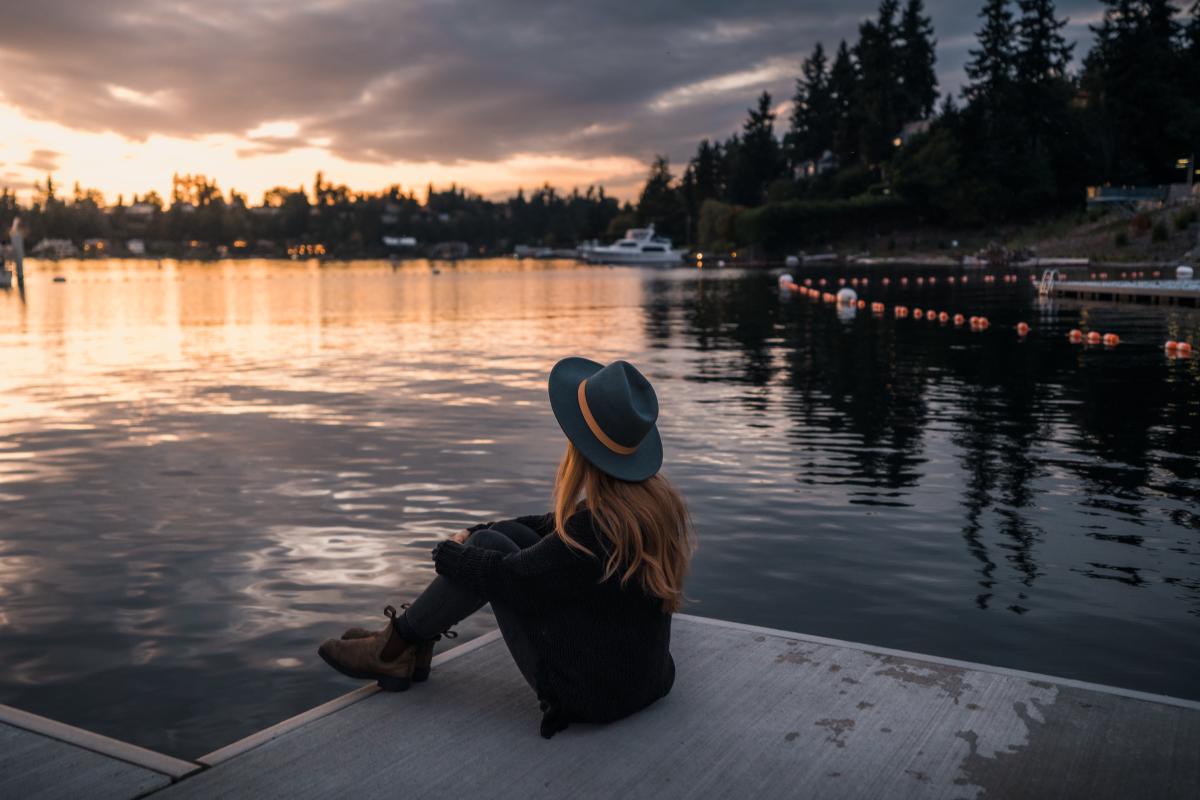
[433,511,674,739]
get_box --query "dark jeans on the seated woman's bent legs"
[404,522,540,690]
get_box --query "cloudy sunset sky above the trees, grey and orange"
[0,0,1100,203]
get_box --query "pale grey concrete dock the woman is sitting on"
[0,614,1200,800]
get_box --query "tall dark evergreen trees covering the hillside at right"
[637,0,1200,248]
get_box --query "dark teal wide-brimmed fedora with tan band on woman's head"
[550,357,662,481]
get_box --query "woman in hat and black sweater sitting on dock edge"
[319,357,696,739]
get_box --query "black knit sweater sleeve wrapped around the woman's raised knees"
[433,515,604,607]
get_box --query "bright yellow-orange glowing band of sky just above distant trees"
[0,103,646,204]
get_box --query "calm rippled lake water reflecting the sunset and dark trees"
[0,259,1200,757]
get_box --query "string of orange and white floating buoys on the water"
[779,272,1192,359]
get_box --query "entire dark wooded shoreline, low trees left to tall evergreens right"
[0,0,1200,263]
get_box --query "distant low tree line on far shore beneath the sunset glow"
[0,173,632,257]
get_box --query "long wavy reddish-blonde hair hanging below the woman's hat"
[554,441,696,614]
